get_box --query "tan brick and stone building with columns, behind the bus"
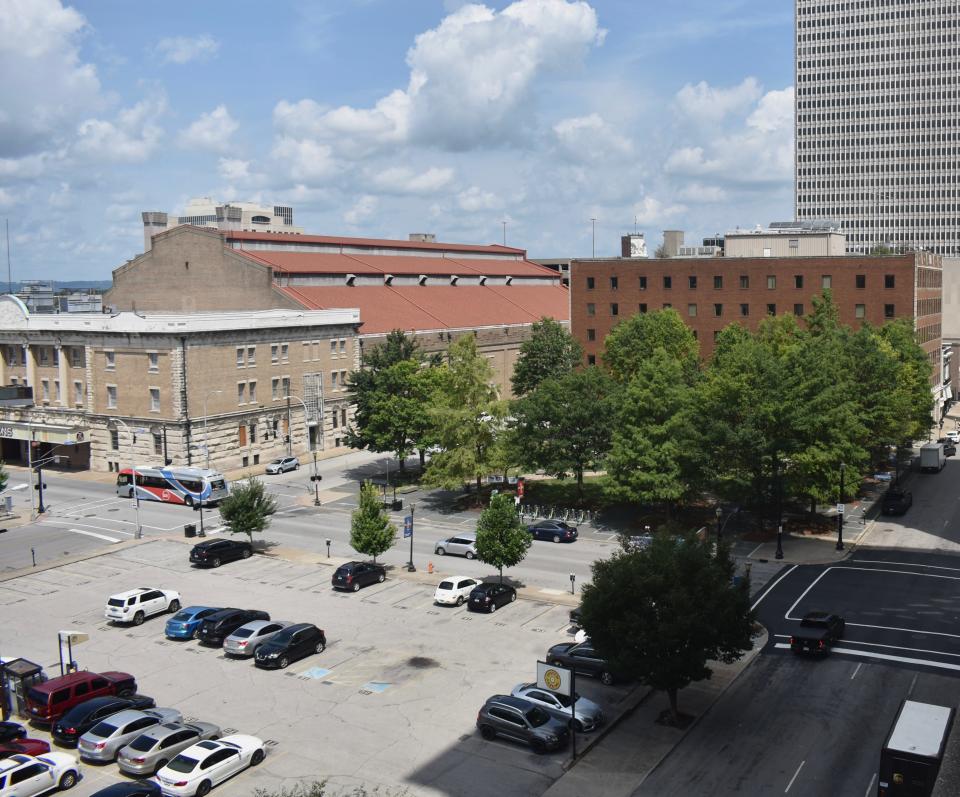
[0,296,360,471]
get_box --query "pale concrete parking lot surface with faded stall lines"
[0,540,630,797]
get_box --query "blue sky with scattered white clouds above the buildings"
[0,0,793,280]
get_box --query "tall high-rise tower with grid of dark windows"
[795,0,960,256]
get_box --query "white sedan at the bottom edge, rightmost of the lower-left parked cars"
[156,733,266,797]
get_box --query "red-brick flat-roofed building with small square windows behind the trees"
[570,252,949,417]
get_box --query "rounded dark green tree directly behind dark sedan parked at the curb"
[512,366,616,497]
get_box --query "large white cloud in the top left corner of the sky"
[0,0,104,158]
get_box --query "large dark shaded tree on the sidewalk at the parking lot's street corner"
[582,534,753,721]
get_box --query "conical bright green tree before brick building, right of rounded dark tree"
[607,349,696,512]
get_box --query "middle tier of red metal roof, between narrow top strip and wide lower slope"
[233,249,560,281]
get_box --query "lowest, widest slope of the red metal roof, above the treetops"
[279,285,570,334]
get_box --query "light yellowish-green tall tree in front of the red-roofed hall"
[424,335,506,502]
